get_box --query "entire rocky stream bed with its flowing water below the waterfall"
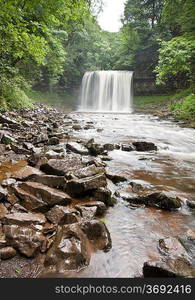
[0,105,195,278]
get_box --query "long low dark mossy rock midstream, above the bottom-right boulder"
[125,192,181,210]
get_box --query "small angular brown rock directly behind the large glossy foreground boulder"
[46,205,80,225]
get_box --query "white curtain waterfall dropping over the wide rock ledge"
[79,71,133,112]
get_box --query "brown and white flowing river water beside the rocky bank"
[42,113,195,278]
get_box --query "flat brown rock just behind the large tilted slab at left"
[29,174,66,190]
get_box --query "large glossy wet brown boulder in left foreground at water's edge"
[45,223,90,273]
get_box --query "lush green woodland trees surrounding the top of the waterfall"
[0,0,195,115]
